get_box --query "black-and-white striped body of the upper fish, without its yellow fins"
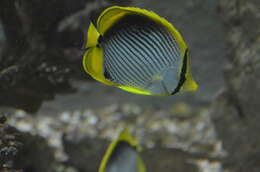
[100,15,182,95]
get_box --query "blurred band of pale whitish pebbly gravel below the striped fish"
[7,103,225,172]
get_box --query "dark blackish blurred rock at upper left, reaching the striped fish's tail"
[0,0,134,113]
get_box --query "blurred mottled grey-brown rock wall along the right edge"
[211,0,260,172]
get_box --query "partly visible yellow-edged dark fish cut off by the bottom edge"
[98,129,146,172]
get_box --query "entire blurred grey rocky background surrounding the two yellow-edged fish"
[0,0,260,172]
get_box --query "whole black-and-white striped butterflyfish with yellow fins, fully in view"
[83,6,198,96]
